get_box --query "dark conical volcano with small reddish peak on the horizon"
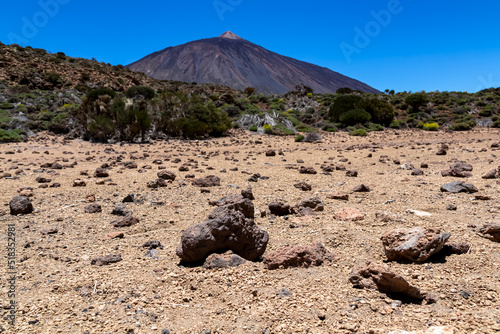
[127,31,379,94]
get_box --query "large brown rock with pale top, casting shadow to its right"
[380,227,450,262]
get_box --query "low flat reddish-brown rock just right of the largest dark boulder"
[264,243,335,269]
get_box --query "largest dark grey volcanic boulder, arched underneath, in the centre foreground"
[176,195,269,262]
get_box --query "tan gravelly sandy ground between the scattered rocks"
[0,129,500,334]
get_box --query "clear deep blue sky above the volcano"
[0,0,500,92]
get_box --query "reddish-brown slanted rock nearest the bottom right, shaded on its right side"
[349,261,425,300]
